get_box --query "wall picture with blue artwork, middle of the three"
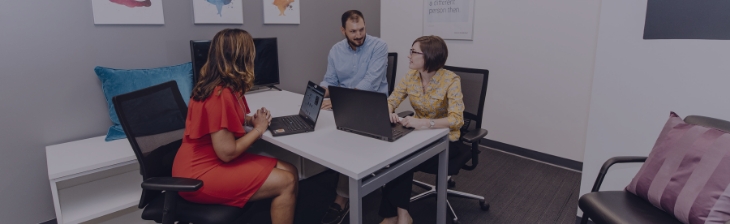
[193,0,243,24]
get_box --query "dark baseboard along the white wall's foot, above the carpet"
[479,138,583,171]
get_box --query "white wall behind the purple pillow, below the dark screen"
[581,0,730,208]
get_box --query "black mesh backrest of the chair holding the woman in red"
[112,81,187,208]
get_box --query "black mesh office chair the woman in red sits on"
[112,81,250,224]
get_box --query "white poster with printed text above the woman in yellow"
[423,0,474,40]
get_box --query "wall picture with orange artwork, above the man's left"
[263,0,299,24]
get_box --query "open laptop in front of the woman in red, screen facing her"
[269,81,325,136]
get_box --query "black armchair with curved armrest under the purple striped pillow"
[578,115,730,224]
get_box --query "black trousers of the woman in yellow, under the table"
[378,142,461,218]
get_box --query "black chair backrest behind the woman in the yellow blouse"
[444,66,489,131]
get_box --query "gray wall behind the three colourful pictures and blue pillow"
[0,0,380,223]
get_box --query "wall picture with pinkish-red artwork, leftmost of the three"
[91,0,165,25]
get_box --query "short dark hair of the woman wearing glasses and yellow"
[411,35,449,72]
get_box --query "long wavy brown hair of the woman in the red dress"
[192,29,256,101]
